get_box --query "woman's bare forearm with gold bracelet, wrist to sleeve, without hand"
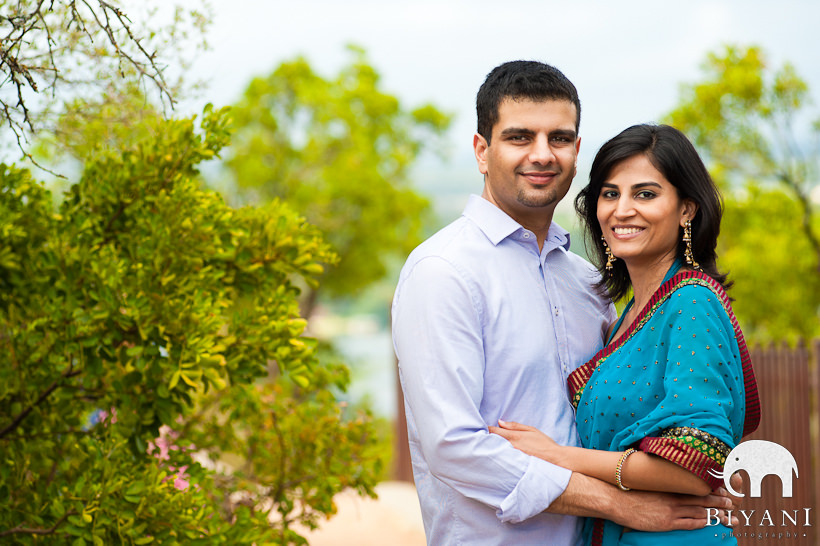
[553,447,712,495]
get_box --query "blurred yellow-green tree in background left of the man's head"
[227,47,450,316]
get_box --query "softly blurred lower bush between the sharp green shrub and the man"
[183,365,384,544]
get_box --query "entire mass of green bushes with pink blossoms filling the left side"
[0,108,380,545]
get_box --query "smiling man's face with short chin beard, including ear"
[473,99,581,226]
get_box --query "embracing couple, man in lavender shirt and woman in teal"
[393,61,760,546]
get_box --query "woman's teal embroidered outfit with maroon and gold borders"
[568,263,760,546]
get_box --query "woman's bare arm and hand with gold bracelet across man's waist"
[489,421,712,495]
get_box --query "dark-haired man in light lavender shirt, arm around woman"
[393,61,728,545]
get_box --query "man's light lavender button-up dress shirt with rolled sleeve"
[393,195,615,546]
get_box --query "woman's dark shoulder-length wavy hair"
[575,124,731,301]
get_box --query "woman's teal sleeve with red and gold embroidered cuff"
[621,285,745,488]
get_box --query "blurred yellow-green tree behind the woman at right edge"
[665,46,820,341]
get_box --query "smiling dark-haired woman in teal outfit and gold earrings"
[490,125,760,545]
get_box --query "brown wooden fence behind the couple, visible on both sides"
[393,340,820,545]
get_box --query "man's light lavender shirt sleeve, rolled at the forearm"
[393,253,571,523]
